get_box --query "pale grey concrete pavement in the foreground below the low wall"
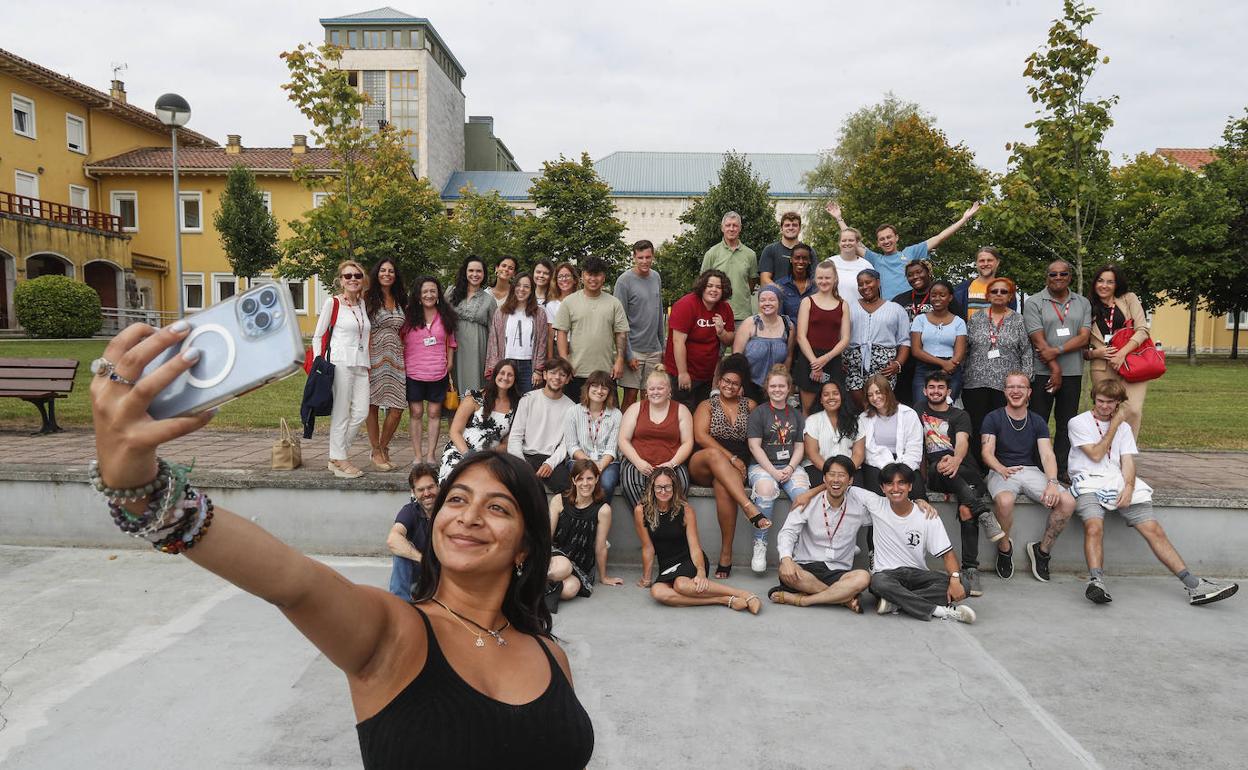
[0,547,1248,770]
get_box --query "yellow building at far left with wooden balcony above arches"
[0,49,216,328]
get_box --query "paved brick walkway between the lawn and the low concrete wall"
[0,428,1248,497]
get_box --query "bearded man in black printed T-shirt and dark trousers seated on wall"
[919,371,1006,597]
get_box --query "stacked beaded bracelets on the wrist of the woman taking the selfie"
[89,459,213,554]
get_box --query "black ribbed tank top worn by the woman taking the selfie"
[356,608,594,770]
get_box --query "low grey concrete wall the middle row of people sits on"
[0,465,1248,575]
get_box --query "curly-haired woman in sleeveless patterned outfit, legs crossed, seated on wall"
[689,353,761,580]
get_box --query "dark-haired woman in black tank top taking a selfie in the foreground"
[91,324,593,769]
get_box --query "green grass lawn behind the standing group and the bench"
[0,339,1248,449]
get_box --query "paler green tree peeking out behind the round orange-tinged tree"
[802,91,936,257]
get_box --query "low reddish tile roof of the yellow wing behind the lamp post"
[86,147,332,173]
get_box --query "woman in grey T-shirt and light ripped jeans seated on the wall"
[745,364,810,574]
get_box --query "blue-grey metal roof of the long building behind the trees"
[442,151,819,201]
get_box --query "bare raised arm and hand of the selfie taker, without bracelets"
[91,322,391,674]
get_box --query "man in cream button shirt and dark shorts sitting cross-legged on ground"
[768,454,937,613]
